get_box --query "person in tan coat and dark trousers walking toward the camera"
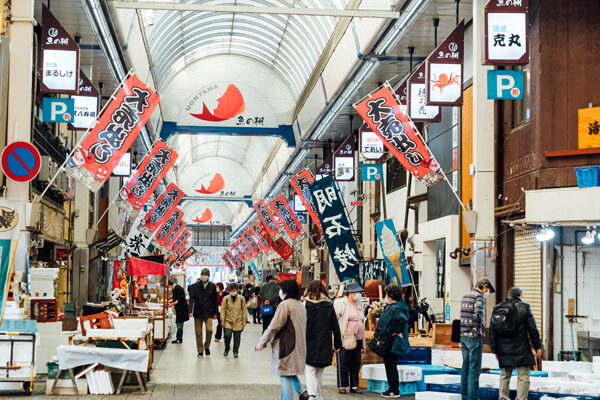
[221,283,247,358]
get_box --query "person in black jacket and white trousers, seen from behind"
[305,281,342,400]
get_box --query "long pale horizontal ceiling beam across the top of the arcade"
[112,0,400,19]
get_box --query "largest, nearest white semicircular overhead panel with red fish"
[178,81,279,128]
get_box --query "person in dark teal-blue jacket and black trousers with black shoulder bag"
[376,284,410,398]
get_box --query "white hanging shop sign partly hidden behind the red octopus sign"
[407,62,442,122]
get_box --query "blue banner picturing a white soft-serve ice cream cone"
[375,219,411,286]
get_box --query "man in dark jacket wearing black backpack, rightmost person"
[490,287,542,400]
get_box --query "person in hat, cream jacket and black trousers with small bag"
[333,282,365,394]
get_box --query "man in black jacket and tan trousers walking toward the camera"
[189,268,219,357]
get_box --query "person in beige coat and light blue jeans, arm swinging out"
[256,279,308,400]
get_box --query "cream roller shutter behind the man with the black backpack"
[514,229,542,335]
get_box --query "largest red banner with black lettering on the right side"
[354,85,443,187]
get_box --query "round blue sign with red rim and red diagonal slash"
[2,142,41,182]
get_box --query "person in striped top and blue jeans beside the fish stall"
[460,278,496,400]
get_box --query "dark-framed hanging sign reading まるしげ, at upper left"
[40,4,79,94]
